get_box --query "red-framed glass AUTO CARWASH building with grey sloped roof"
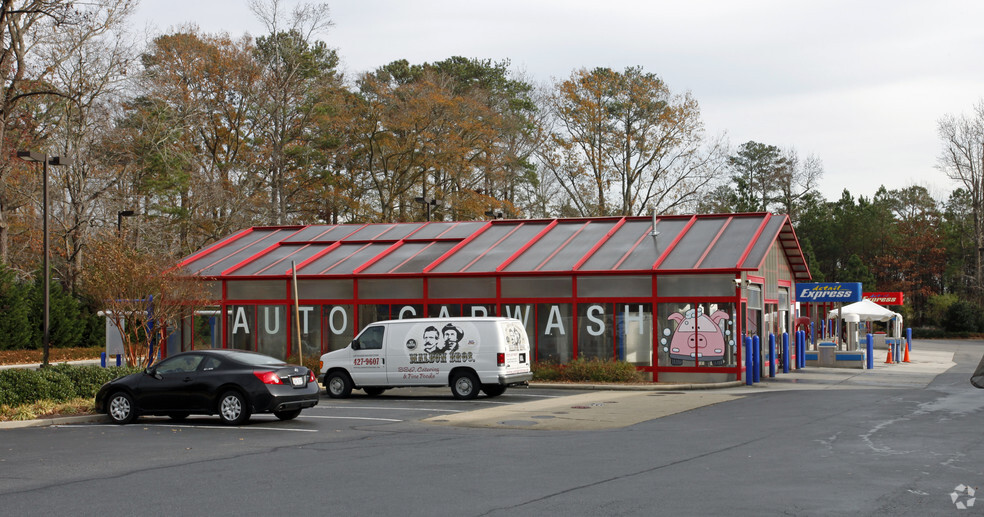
[173,213,810,382]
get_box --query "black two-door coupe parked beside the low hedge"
[96,350,320,425]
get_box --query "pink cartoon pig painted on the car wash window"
[660,307,735,366]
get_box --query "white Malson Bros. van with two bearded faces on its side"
[321,318,533,399]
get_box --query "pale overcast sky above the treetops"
[136,0,984,200]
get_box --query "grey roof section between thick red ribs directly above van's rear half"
[434,222,547,273]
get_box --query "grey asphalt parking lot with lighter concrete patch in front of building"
[0,341,984,515]
